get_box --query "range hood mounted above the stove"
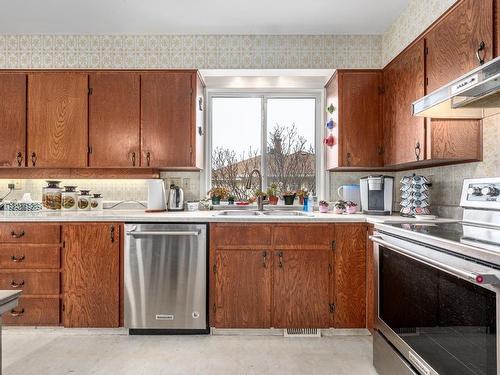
[412,57,500,119]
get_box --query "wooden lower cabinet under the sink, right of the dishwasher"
[210,224,367,328]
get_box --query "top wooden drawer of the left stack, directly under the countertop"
[0,223,61,244]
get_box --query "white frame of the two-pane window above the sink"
[200,89,330,200]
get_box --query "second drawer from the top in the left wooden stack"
[0,244,60,269]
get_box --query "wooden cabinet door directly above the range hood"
[425,0,493,93]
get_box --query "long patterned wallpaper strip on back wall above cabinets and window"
[0,35,382,69]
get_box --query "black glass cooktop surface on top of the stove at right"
[390,222,500,251]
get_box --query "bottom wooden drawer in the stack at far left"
[2,297,59,325]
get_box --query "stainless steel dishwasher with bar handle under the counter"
[124,223,208,334]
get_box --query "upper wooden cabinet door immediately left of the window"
[141,72,196,167]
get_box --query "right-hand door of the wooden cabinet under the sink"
[272,249,330,328]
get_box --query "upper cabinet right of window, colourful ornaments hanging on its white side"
[326,70,383,169]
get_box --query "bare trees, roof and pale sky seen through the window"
[212,97,316,200]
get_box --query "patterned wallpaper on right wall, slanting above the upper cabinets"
[382,0,456,65]
